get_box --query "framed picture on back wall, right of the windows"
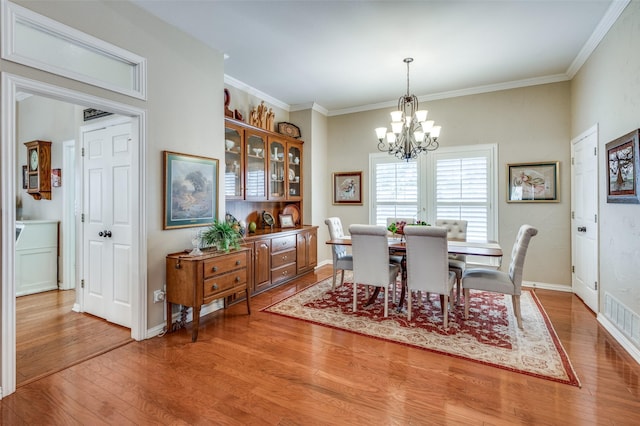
[507,161,560,203]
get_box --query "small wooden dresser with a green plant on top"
[166,248,251,342]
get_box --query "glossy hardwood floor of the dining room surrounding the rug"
[0,267,640,425]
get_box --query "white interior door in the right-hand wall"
[571,126,599,313]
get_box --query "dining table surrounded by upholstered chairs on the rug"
[326,235,503,311]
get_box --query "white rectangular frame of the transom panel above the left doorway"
[1,0,147,100]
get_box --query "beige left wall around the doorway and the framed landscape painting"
[0,0,224,328]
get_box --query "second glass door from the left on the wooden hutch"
[245,130,267,200]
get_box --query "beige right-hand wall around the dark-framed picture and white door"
[571,2,640,336]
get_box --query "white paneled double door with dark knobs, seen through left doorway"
[82,123,135,327]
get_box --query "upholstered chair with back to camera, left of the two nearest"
[349,225,400,318]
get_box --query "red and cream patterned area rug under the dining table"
[263,275,580,386]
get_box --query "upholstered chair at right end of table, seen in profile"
[462,225,538,328]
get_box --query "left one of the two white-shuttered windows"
[369,153,420,226]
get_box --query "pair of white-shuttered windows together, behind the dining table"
[369,144,498,241]
